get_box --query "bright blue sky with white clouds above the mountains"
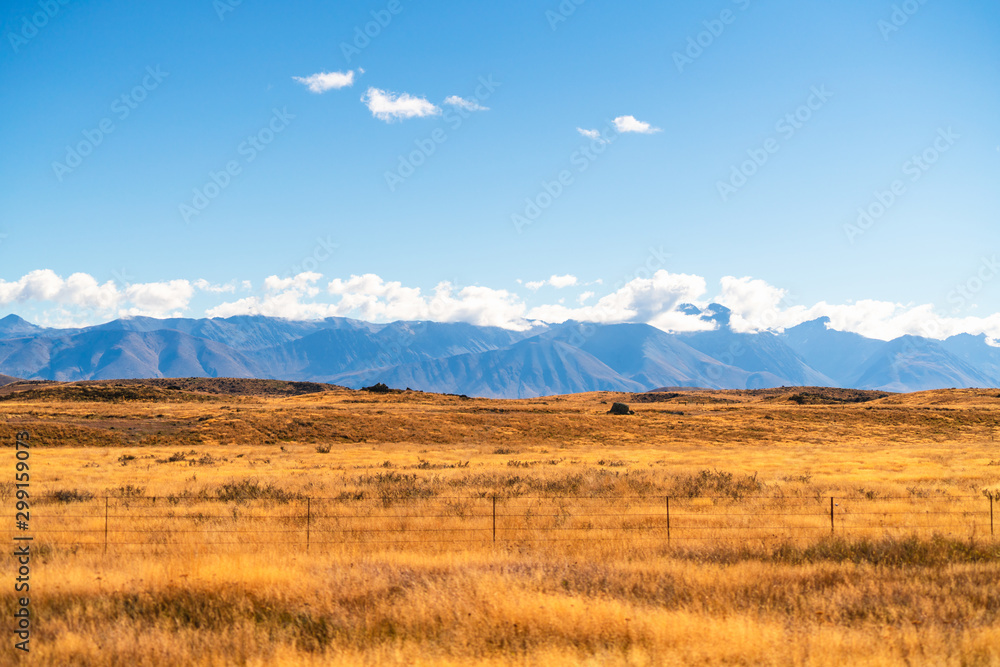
[0,0,1000,338]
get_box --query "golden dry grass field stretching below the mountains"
[0,380,1000,665]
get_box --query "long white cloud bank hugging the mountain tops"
[0,269,1000,340]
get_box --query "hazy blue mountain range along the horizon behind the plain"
[0,304,1000,398]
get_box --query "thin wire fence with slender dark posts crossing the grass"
[5,494,995,551]
